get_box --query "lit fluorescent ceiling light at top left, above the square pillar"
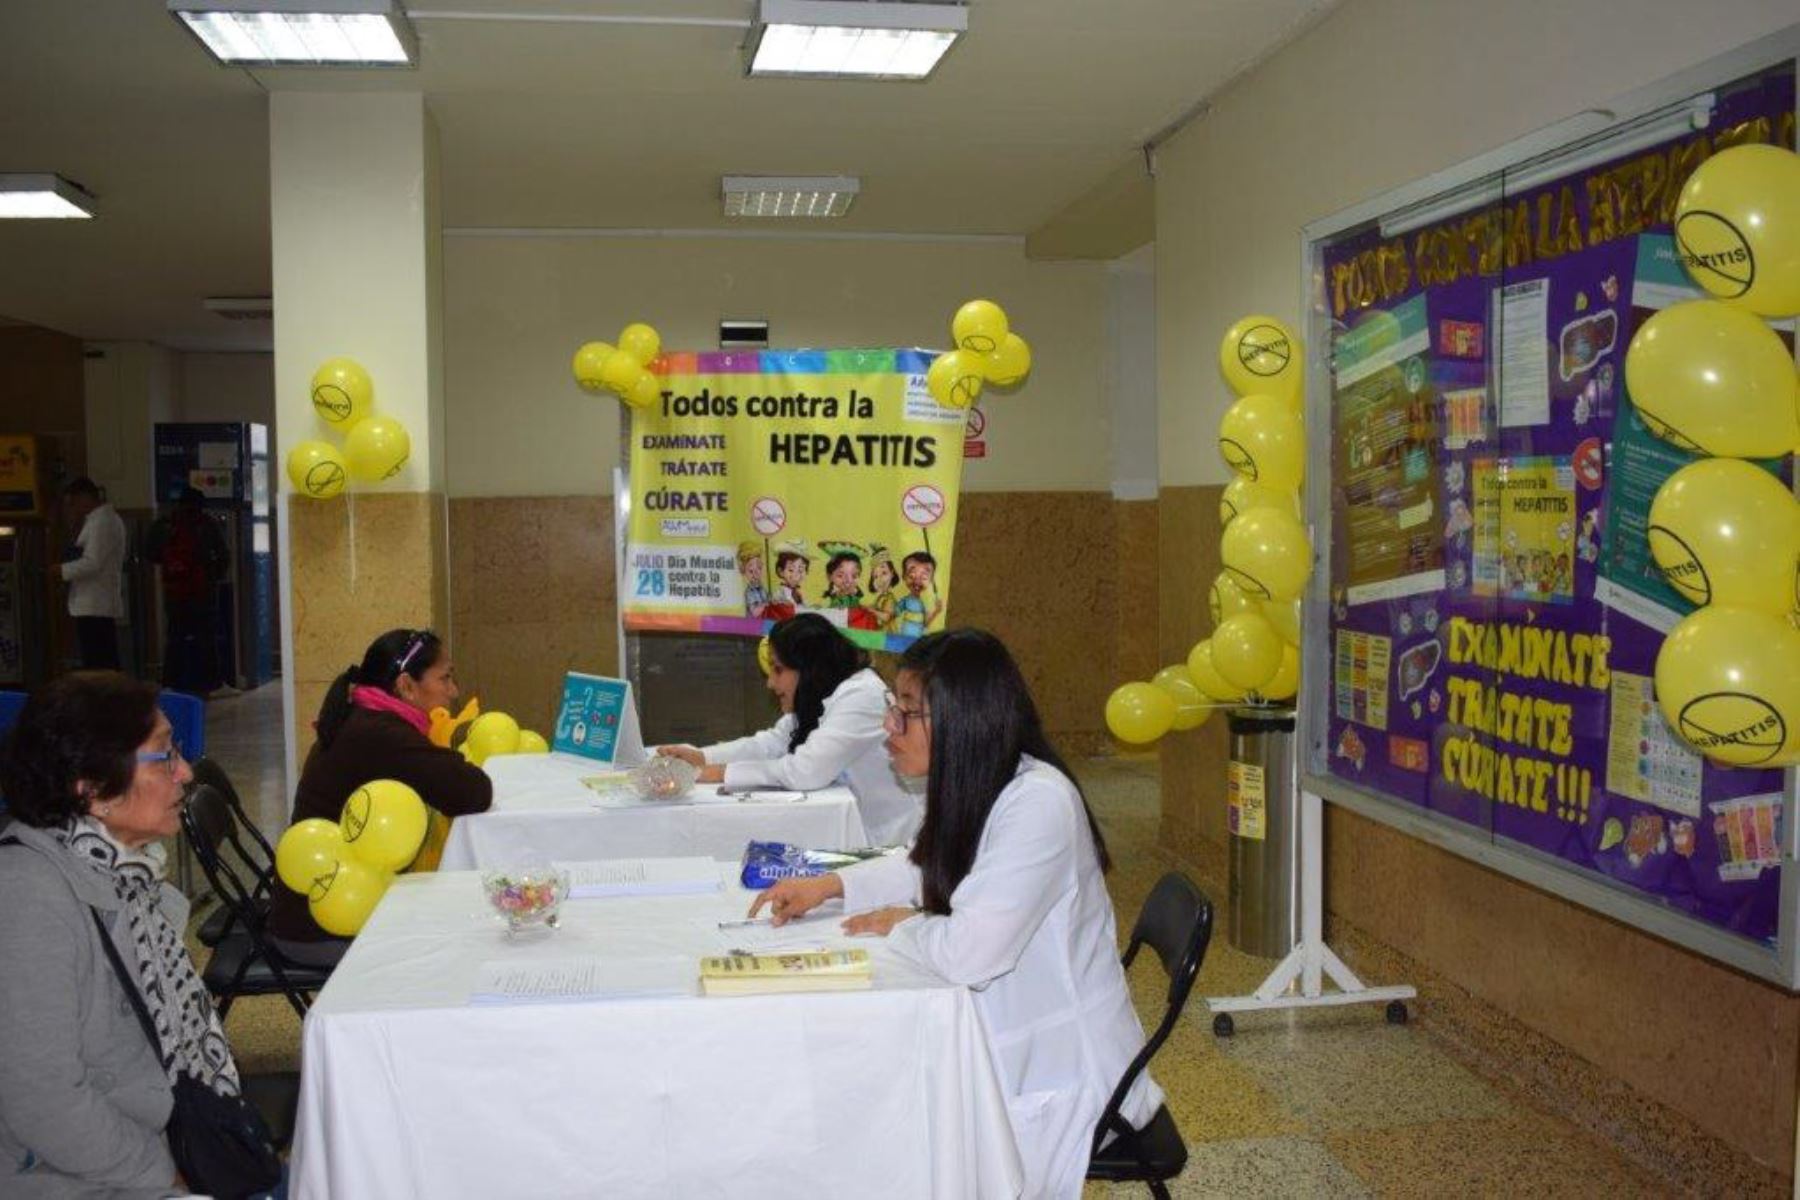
[169,0,419,67]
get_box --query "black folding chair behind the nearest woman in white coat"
[1087,871,1213,1200]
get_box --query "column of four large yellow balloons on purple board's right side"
[1625,146,1800,766]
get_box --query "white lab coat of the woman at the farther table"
[700,667,925,849]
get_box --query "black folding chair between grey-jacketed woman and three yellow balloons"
[182,784,331,1020]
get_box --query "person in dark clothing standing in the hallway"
[148,488,230,696]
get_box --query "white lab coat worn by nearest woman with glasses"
[839,757,1163,1200]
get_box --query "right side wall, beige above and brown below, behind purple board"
[1156,0,1800,1171]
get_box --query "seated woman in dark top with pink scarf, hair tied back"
[268,630,493,966]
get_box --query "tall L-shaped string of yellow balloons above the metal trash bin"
[1107,317,1312,745]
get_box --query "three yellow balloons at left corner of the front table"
[275,779,427,937]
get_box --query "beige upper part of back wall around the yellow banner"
[445,232,1111,497]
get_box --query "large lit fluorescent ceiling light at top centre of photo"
[745,0,968,79]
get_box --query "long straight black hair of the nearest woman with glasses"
[900,630,1112,916]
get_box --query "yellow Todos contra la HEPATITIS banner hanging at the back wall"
[623,349,968,649]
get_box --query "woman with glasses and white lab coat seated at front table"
[751,630,1163,1198]
